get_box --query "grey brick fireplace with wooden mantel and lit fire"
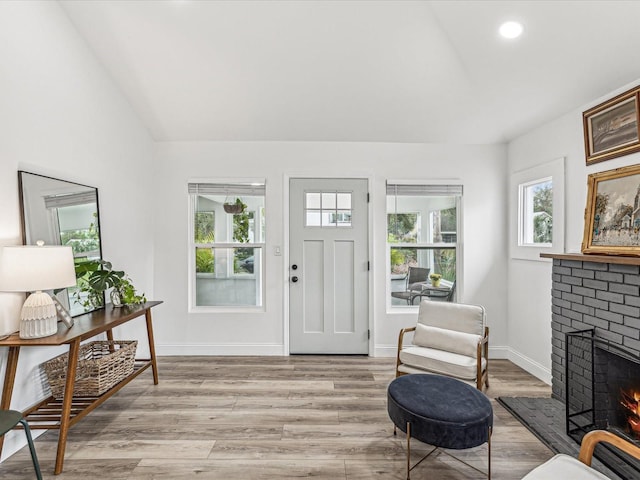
[543,254,640,478]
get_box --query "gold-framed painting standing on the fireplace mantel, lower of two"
[582,165,640,255]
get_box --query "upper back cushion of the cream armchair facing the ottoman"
[418,300,485,335]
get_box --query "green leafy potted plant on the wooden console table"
[74,260,147,308]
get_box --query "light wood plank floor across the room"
[0,356,552,480]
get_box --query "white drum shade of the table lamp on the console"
[0,245,76,292]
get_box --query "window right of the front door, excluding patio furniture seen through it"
[387,184,462,307]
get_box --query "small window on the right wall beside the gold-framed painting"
[518,177,553,247]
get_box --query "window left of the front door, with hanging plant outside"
[189,183,265,309]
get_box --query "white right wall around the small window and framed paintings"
[508,82,640,383]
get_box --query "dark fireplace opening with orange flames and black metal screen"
[565,329,640,478]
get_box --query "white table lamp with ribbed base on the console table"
[0,241,76,338]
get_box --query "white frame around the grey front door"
[282,173,375,357]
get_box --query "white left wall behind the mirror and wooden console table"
[0,1,154,457]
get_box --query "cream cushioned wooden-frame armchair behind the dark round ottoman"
[396,300,489,390]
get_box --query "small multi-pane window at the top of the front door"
[304,191,352,228]
